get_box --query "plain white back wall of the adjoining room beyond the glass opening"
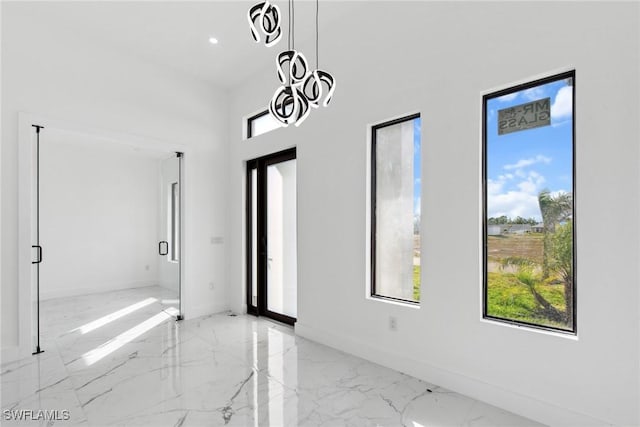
[40,137,159,299]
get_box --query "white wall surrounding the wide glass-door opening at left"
[1,2,227,360]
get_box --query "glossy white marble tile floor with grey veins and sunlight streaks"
[0,287,539,427]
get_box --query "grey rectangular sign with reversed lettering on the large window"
[498,98,551,135]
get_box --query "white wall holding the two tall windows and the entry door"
[229,1,640,425]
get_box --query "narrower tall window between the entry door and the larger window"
[371,114,421,303]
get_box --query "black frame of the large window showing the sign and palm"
[481,69,578,336]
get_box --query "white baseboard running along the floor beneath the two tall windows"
[295,322,611,427]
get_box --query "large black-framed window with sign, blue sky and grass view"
[483,71,576,332]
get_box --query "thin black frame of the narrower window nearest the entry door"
[369,113,422,306]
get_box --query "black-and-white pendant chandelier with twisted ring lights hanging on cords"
[248,0,336,127]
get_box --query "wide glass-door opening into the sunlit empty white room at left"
[27,125,184,358]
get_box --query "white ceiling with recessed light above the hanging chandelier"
[13,0,364,87]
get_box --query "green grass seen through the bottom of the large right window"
[487,273,566,327]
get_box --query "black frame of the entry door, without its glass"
[245,147,296,325]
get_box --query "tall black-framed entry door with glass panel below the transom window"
[246,148,298,325]
